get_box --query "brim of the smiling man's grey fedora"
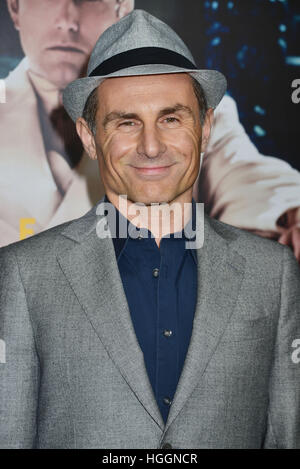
[63,64,227,122]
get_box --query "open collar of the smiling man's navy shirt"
[104,194,197,263]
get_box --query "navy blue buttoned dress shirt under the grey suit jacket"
[105,196,197,423]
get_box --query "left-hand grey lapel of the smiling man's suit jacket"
[58,203,164,430]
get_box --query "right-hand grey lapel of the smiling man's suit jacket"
[165,207,245,432]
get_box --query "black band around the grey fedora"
[89,47,197,77]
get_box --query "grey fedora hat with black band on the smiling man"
[63,10,227,122]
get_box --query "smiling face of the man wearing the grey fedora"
[81,73,212,205]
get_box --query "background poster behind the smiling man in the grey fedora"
[0,0,300,250]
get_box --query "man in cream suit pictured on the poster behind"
[0,0,300,261]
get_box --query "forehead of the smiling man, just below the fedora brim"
[97,73,196,111]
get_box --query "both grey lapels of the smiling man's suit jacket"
[58,199,245,432]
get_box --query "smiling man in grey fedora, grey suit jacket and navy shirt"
[0,10,300,449]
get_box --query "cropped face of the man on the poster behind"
[8,0,133,88]
